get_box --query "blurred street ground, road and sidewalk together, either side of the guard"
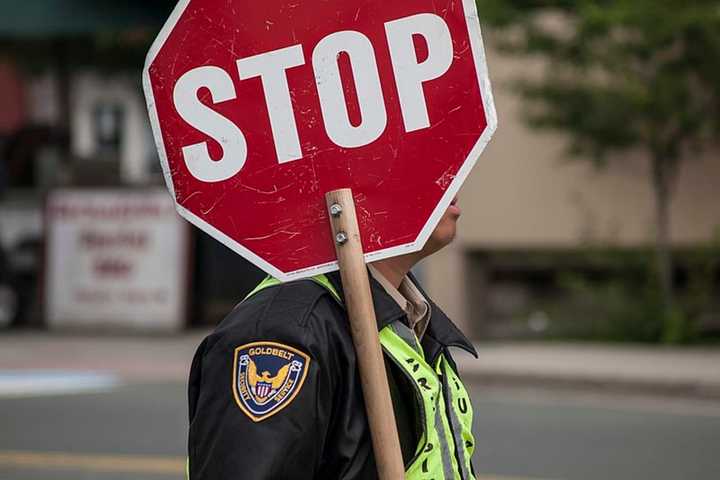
[0,332,720,480]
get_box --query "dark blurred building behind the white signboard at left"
[0,0,261,325]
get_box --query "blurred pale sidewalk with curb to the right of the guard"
[458,342,720,400]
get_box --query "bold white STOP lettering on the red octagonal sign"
[173,13,453,182]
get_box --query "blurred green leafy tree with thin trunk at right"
[478,0,720,341]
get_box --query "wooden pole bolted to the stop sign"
[325,189,405,480]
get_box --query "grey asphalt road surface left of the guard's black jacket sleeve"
[0,382,187,480]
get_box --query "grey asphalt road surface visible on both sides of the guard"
[0,381,720,480]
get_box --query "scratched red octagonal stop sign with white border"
[143,0,496,280]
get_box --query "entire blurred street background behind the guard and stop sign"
[0,0,720,480]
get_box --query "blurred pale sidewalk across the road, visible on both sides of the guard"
[0,331,720,401]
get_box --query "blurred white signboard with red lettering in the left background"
[45,189,189,331]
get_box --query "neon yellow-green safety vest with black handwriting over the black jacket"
[245,275,475,480]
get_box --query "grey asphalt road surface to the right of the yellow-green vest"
[473,387,720,480]
